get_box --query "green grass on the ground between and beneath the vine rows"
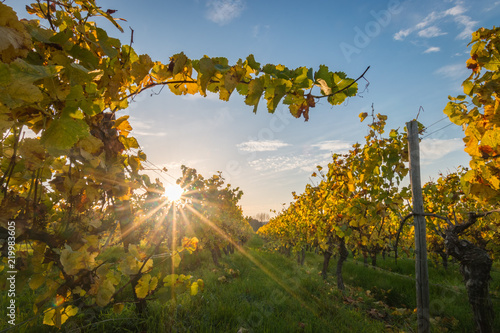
[0,237,500,333]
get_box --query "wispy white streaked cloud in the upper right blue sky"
[393,3,478,41]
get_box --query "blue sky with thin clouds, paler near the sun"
[5,0,500,216]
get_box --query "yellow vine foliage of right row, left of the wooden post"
[259,115,408,260]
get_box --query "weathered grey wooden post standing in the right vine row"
[406,120,430,333]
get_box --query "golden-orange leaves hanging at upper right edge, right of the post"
[444,28,500,203]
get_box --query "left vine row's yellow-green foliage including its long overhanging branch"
[0,0,355,327]
